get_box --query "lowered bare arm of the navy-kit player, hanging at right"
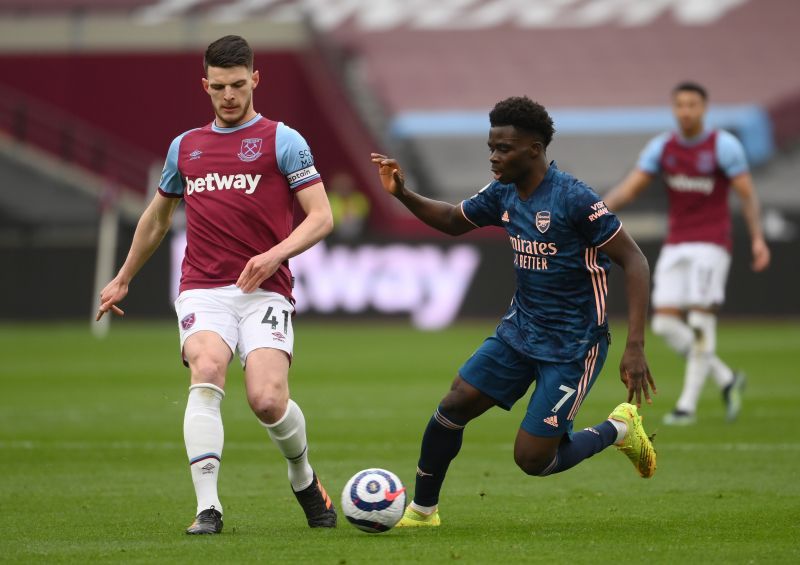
[602,228,658,406]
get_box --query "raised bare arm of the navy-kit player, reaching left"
[371,153,475,235]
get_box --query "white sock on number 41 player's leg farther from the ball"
[183,383,225,514]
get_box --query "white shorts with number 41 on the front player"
[175,285,294,366]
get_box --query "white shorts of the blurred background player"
[653,242,731,310]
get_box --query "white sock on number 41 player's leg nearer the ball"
[261,398,314,492]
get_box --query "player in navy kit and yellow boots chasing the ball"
[372,97,656,526]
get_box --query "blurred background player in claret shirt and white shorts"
[605,82,770,425]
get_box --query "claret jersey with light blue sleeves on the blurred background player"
[638,130,748,249]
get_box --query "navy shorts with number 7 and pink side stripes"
[458,335,608,437]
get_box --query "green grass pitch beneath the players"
[0,318,800,564]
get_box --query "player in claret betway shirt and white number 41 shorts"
[98,36,336,534]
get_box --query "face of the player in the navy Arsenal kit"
[487,126,541,184]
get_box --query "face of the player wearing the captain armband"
[203,67,259,127]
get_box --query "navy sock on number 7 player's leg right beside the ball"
[414,407,464,506]
